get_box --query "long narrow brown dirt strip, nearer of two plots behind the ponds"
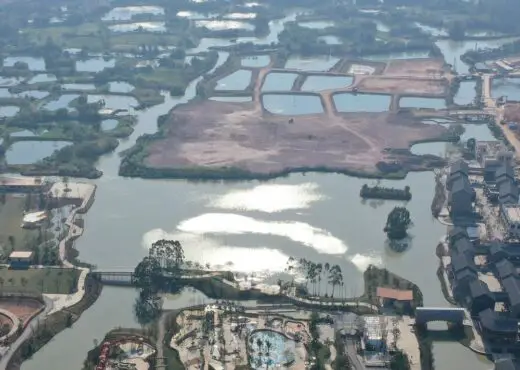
[356,76,447,96]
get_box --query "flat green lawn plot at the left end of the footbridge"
[0,267,79,294]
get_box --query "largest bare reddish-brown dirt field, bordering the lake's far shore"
[146,101,445,174]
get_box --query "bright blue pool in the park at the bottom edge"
[248,330,296,370]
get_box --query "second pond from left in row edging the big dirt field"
[262,94,323,115]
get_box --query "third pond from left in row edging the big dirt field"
[333,93,392,113]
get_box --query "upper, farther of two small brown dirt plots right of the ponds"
[383,58,445,78]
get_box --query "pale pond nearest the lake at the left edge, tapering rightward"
[5,141,71,165]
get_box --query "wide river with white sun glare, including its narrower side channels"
[22,11,500,370]
